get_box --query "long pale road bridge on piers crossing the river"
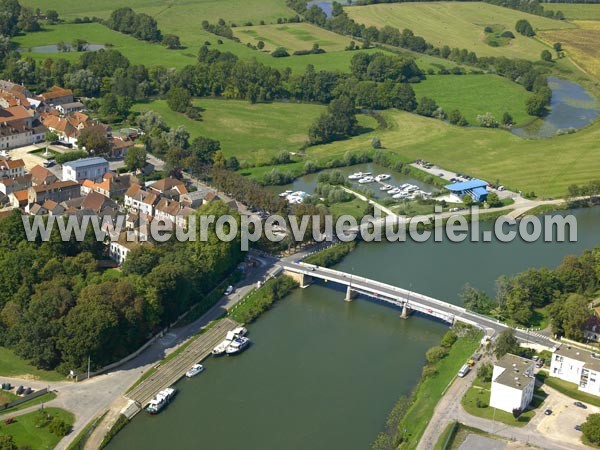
[279,260,556,349]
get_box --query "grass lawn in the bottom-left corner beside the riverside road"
[1,408,75,450]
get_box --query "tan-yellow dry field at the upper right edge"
[540,20,600,80]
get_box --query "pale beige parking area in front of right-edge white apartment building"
[534,386,600,448]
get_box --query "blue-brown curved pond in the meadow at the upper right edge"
[512,77,600,138]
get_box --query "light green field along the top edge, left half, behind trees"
[20,0,295,25]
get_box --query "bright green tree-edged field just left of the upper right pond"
[412,75,532,125]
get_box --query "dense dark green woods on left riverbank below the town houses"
[0,202,241,373]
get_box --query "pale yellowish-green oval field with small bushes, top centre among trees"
[233,23,351,53]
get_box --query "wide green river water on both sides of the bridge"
[107,208,600,450]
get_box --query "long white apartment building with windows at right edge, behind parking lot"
[550,344,600,396]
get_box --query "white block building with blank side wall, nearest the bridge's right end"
[490,353,535,413]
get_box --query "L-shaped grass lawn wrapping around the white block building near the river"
[461,378,539,427]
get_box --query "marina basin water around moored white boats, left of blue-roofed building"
[267,163,435,200]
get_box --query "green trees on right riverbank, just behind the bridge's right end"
[461,247,600,340]
